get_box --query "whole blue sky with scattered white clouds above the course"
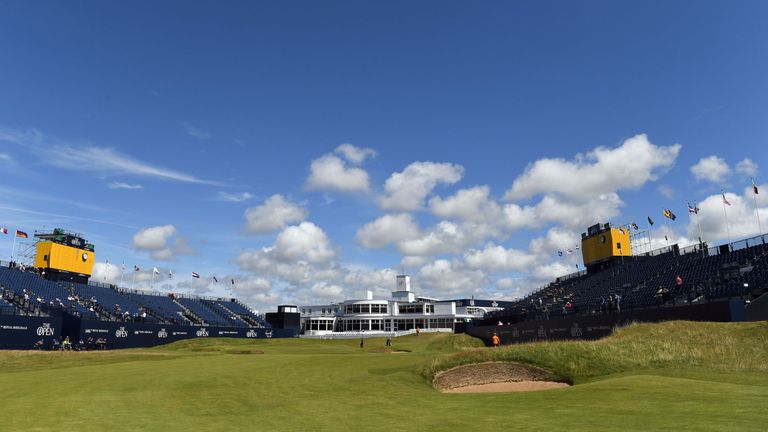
[0,1,768,312]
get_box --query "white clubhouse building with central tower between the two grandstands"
[299,275,507,335]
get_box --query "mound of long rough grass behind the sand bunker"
[422,321,768,383]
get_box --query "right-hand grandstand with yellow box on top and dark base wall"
[467,224,768,343]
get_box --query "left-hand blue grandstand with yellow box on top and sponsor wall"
[0,228,298,349]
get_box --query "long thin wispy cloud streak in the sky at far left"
[0,127,218,185]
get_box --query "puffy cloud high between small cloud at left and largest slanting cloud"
[379,162,464,211]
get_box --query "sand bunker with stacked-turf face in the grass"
[432,362,568,393]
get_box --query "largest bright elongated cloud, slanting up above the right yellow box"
[504,134,681,201]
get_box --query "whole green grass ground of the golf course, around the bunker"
[0,322,768,432]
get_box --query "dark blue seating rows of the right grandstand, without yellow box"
[494,236,768,319]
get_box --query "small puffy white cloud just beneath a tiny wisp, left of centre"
[305,154,369,192]
